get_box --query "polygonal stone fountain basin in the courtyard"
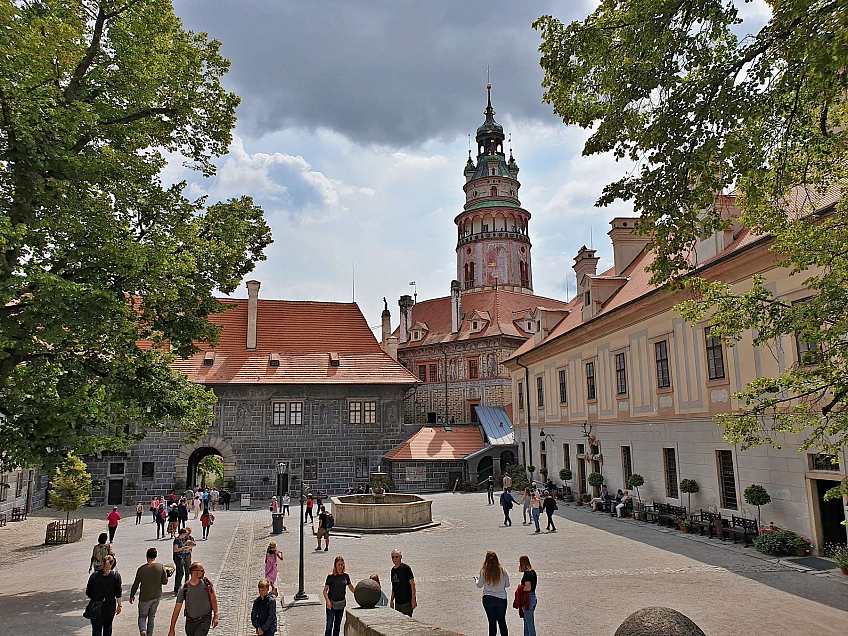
[331,493,439,534]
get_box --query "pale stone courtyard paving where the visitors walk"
[0,494,848,636]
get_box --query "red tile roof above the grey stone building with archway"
[173,298,417,384]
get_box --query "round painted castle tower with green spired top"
[454,84,533,294]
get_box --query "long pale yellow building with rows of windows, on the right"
[505,197,846,546]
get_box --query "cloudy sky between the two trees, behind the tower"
[163,0,768,333]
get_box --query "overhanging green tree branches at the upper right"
[534,0,848,455]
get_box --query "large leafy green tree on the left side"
[0,0,271,469]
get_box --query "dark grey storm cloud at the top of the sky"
[175,0,590,146]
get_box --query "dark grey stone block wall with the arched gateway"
[86,385,415,504]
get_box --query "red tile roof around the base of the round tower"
[394,290,566,350]
